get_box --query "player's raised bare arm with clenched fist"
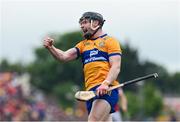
[44,38,77,62]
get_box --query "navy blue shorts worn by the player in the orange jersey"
[86,85,118,114]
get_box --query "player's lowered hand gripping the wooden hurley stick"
[96,83,109,96]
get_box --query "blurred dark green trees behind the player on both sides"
[0,31,180,117]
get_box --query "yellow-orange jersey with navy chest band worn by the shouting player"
[75,34,122,90]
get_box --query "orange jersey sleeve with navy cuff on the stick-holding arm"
[107,38,122,57]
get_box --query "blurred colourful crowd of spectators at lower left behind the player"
[0,72,86,121]
